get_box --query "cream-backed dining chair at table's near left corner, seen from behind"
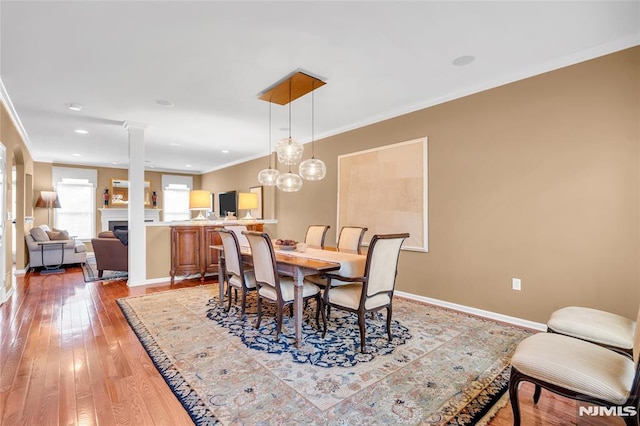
[243,231,324,341]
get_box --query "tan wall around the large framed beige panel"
[202,47,640,322]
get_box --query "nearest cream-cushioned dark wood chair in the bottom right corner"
[509,302,640,426]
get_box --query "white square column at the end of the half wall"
[124,121,147,286]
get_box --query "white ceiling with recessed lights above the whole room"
[0,0,640,173]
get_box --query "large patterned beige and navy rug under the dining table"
[118,284,530,425]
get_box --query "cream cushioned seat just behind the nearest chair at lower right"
[547,306,636,356]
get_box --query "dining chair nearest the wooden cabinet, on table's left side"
[218,229,257,318]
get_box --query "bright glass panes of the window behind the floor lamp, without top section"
[53,179,96,240]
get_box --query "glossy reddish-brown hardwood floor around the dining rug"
[0,267,624,426]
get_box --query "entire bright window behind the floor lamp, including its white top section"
[51,167,98,240]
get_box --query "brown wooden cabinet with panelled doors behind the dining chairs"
[169,223,264,284]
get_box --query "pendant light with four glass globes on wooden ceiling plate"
[258,71,327,192]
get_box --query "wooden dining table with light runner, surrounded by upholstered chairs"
[210,245,367,347]
